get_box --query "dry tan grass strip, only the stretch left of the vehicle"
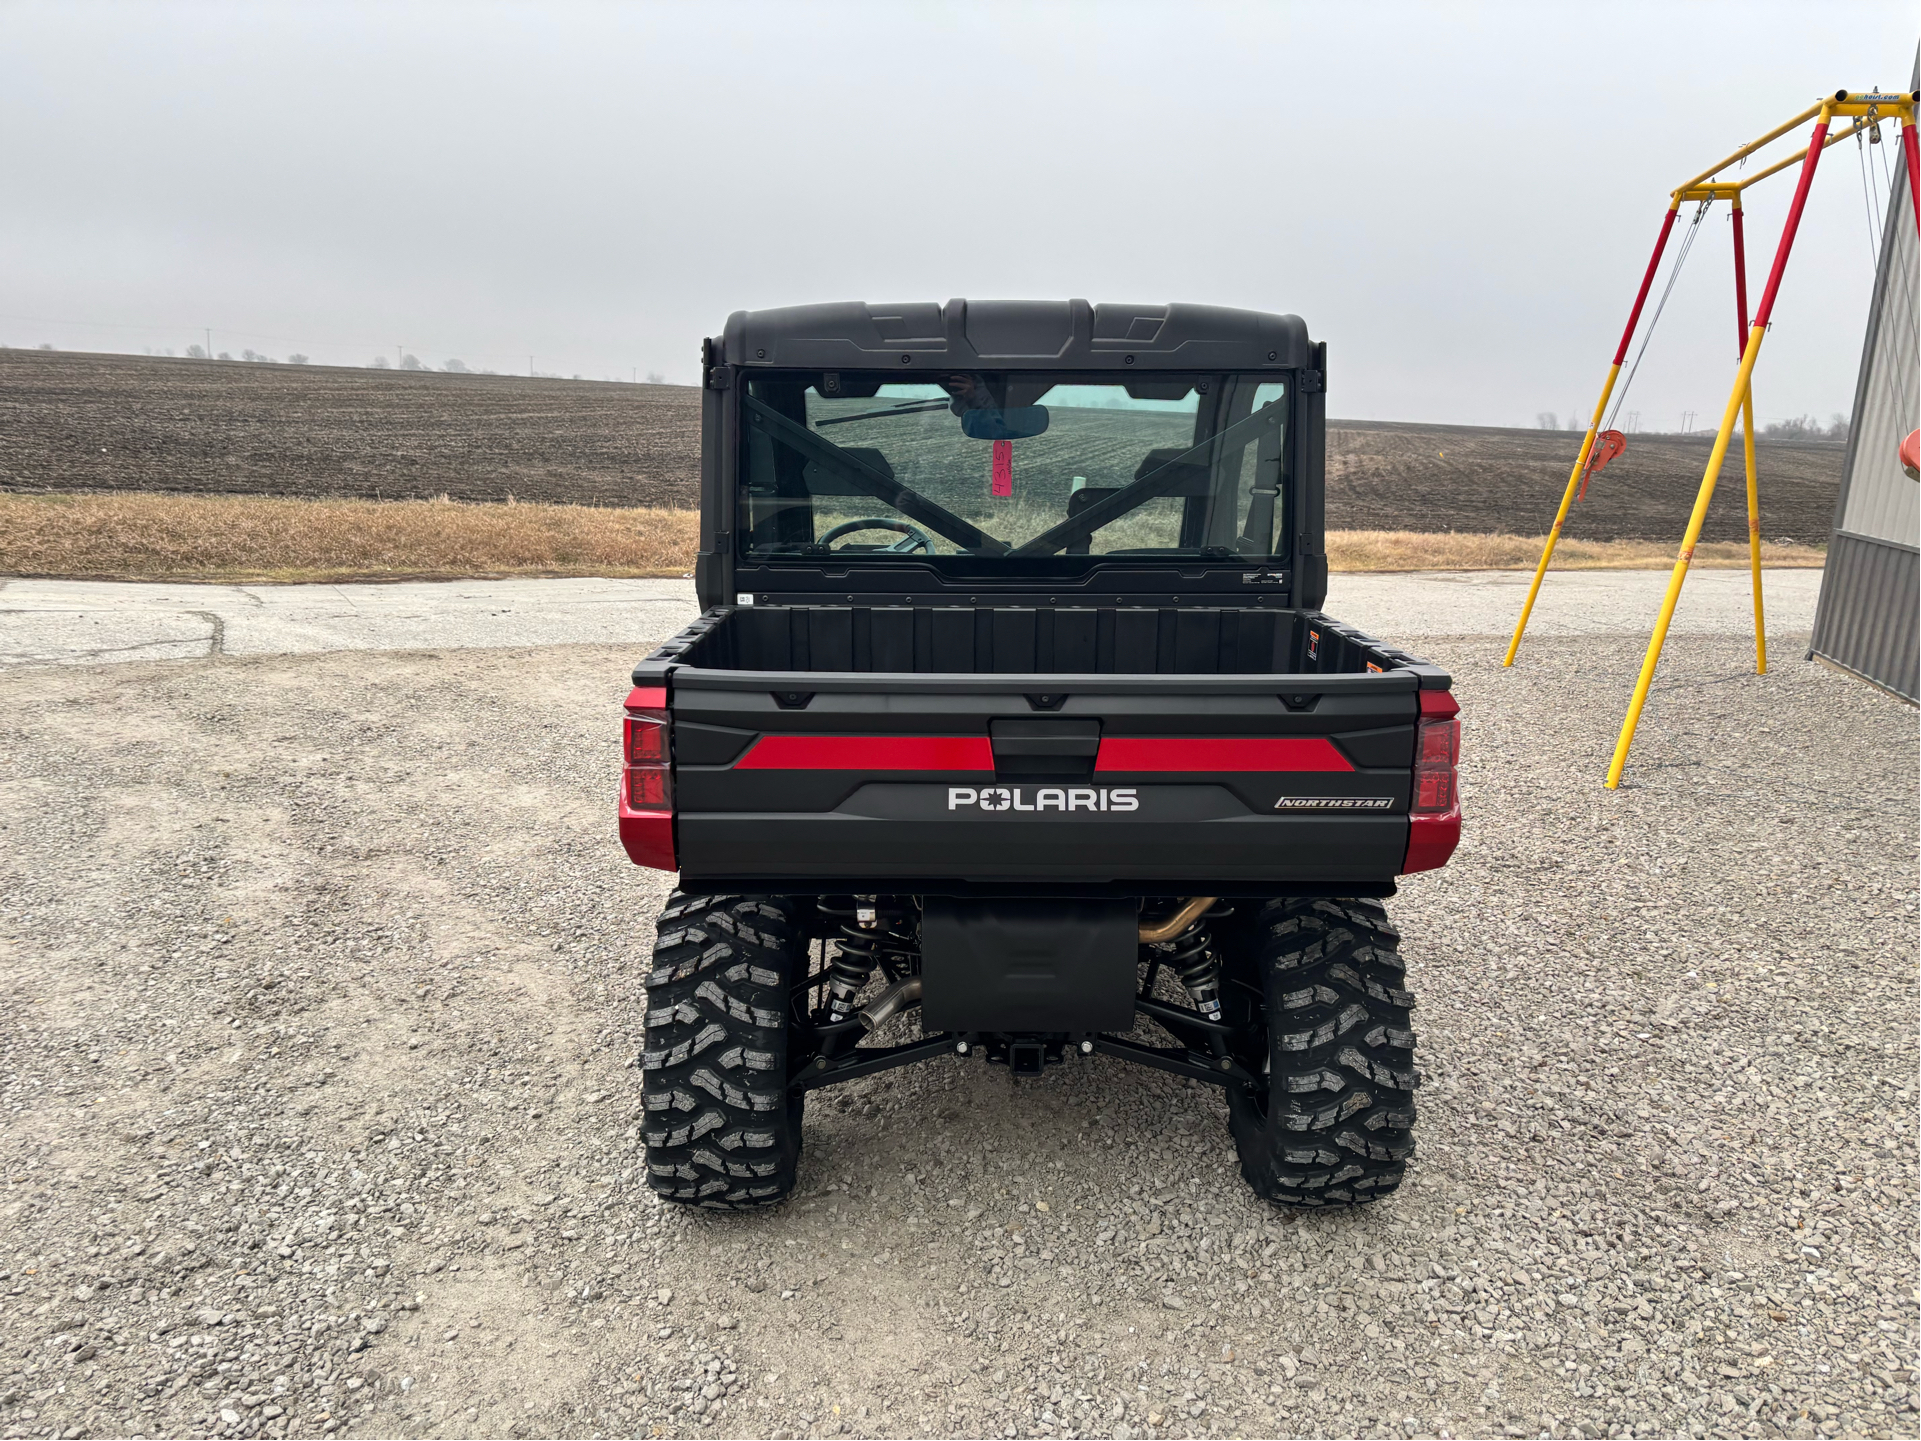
[0,492,699,582]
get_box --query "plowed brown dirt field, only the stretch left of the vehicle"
[0,350,701,505]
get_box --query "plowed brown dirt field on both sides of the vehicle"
[0,350,1842,542]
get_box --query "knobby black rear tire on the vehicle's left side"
[640,891,807,1210]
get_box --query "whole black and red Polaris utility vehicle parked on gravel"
[620,300,1460,1209]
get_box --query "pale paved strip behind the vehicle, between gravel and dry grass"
[0,571,1821,667]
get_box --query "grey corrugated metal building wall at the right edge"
[1808,101,1921,701]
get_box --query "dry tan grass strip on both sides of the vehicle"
[0,492,1823,582]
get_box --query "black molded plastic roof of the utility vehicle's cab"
[717,300,1314,371]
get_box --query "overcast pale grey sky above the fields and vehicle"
[0,0,1917,428]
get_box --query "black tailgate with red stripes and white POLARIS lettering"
[670,672,1425,893]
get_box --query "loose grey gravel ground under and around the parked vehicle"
[0,638,1917,1437]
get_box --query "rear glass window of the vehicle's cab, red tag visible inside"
[742,371,1291,573]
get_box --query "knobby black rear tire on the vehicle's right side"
[1228,899,1416,1207]
